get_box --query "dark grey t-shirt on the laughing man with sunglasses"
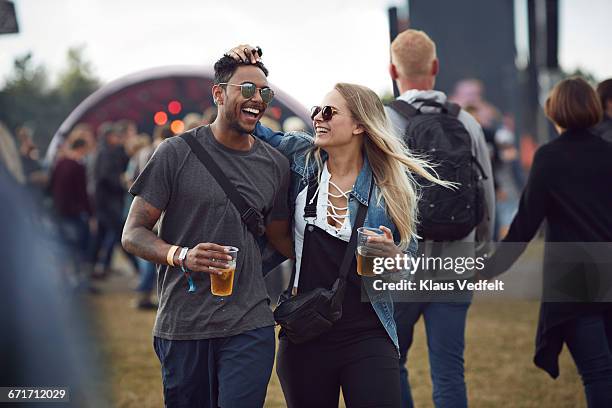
[130,126,289,340]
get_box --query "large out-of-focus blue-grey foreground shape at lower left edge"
[0,163,110,408]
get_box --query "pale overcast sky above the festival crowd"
[0,0,612,106]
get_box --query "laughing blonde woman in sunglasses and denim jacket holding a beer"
[230,46,445,408]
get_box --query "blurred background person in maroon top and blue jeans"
[49,139,97,293]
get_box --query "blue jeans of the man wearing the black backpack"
[394,293,471,408]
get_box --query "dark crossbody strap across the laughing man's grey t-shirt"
[180,132,263,238]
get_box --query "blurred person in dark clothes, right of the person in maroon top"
[93,124,129,278]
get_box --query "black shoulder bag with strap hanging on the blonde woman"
[274,177,373,344]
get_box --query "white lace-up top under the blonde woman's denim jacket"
[293,163,352,287]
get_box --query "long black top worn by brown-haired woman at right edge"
[483,130,612,377]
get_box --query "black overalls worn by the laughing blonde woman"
[276,182,400,408]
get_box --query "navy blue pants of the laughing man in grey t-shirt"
[153,326,275,408]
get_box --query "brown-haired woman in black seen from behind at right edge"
[481,77,612,408]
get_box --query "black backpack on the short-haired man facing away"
[389,99,487,241]
